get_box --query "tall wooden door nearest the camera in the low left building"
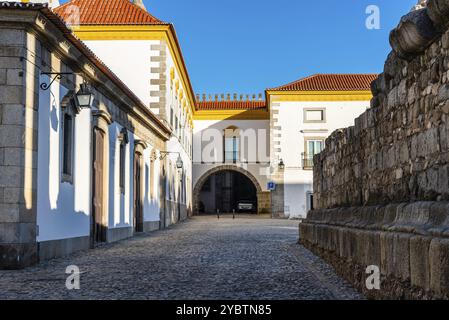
[92,128,106,244]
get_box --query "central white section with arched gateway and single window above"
[193,95,271,214]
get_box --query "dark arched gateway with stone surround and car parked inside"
[193,165,269,215]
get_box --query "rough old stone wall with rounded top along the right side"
[300,0,449,298]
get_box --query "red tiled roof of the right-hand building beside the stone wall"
[268,74,378,91]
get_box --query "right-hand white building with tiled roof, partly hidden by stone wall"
[266,74,377,218]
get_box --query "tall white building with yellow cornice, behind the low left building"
[55,0,195,225]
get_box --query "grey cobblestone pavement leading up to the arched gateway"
[0,217,362,300]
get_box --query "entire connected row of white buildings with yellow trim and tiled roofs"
[0,0,376,268]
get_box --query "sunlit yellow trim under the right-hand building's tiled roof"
[267,90,373,102]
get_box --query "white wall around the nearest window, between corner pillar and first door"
[37,76,91,242]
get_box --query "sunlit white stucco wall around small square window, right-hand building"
[272,101,370,217]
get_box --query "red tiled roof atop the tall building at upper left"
[54,0,166,25]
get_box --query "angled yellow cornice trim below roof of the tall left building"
[74,25,195,114]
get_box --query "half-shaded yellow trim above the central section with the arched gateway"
[193,110,270,120]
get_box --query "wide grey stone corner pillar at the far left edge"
[0,28,41,269]
